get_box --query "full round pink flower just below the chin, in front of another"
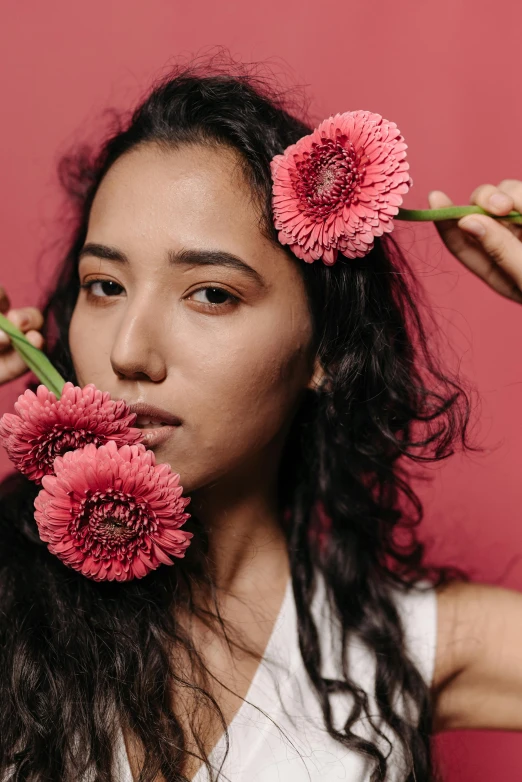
[34,440,192,581]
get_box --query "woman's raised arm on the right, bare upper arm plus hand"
[429,184,522,731]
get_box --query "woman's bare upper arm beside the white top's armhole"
[432,583,522,732]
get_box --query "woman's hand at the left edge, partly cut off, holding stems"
[0,286,44,385]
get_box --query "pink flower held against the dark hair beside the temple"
[270,111,413,266]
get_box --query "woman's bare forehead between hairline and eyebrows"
[86,144,296,284]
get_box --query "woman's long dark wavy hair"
[0,53,477,782]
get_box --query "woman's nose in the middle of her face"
[110,304,167,383]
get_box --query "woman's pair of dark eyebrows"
[78,242,267,288]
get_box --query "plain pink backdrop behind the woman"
[0,0,522,782]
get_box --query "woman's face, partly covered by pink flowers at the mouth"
[70,145,315,493]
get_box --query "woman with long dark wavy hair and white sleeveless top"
[0,62,522,782]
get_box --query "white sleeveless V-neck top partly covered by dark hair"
[115,575,437,782]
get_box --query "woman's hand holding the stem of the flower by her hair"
[428,179,522,304]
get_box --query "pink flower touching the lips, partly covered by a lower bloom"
[0,382,143,484]
